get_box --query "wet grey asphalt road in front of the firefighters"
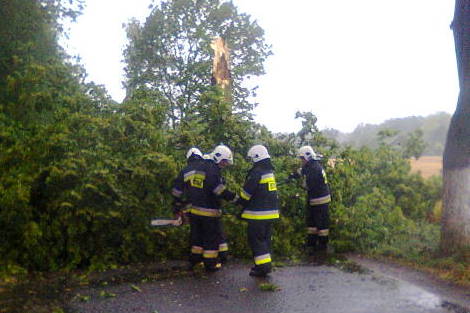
[67,263,470,313]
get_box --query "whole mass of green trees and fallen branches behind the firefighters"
[0,0,452,272]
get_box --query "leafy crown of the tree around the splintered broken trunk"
[125,0,271,127]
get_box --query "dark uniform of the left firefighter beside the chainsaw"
[172,158,235,270]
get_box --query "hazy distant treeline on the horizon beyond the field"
[322,112,451,156]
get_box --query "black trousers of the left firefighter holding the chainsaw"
[189,214,220,268]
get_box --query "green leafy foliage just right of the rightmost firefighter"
[330,146,441,251]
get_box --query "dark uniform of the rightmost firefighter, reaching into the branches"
[301,159,331,251]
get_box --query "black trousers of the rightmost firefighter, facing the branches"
[306,203,330,250]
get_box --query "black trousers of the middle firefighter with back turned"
[247,220,272,273]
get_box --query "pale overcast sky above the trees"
[64,0,458,132]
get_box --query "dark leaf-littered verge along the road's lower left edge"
[0,261,193,313]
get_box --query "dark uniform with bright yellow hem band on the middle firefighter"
[238,159,279,276]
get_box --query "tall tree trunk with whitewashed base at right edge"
[441,0,470,254]
